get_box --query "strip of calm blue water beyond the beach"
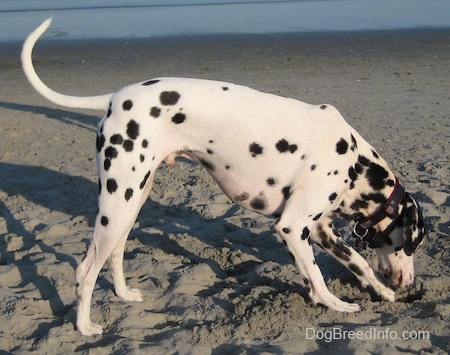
[0,0,450,42]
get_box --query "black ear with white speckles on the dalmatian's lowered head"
[403,194,428,256]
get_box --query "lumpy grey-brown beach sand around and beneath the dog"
[0,31,450,354]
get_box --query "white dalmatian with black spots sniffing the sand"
[22,19,426,335]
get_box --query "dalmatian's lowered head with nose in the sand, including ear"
[376,193,427,287]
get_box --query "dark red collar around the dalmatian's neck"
[353,178,405,238]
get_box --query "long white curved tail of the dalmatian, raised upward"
[21,17,113,111]
